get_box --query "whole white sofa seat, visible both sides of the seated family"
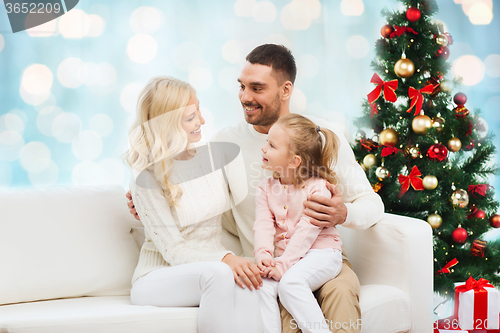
[0,285,410,333]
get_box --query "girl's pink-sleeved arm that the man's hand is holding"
[276,181,331,275]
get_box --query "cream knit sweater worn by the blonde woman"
[130,145,236,284]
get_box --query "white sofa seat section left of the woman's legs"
[0,296,198,333]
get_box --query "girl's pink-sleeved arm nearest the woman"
[253,178,276,264]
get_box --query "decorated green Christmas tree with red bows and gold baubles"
[353,0,500,297]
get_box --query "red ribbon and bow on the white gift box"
[455,276,495,329]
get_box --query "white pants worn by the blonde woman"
[130,261,262,333]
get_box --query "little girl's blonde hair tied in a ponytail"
[273,113,340,187]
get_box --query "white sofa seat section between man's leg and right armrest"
[359,284,411,333]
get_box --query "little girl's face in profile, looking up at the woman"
[261,124,293,175]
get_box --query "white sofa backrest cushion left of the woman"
[0,186,139,304]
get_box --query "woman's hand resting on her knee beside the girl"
[222,254,262,290]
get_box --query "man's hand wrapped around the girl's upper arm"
[304,182,347,228]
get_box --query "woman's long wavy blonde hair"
[125,76,196,206]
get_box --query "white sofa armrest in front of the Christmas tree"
[339,213,433,332]
